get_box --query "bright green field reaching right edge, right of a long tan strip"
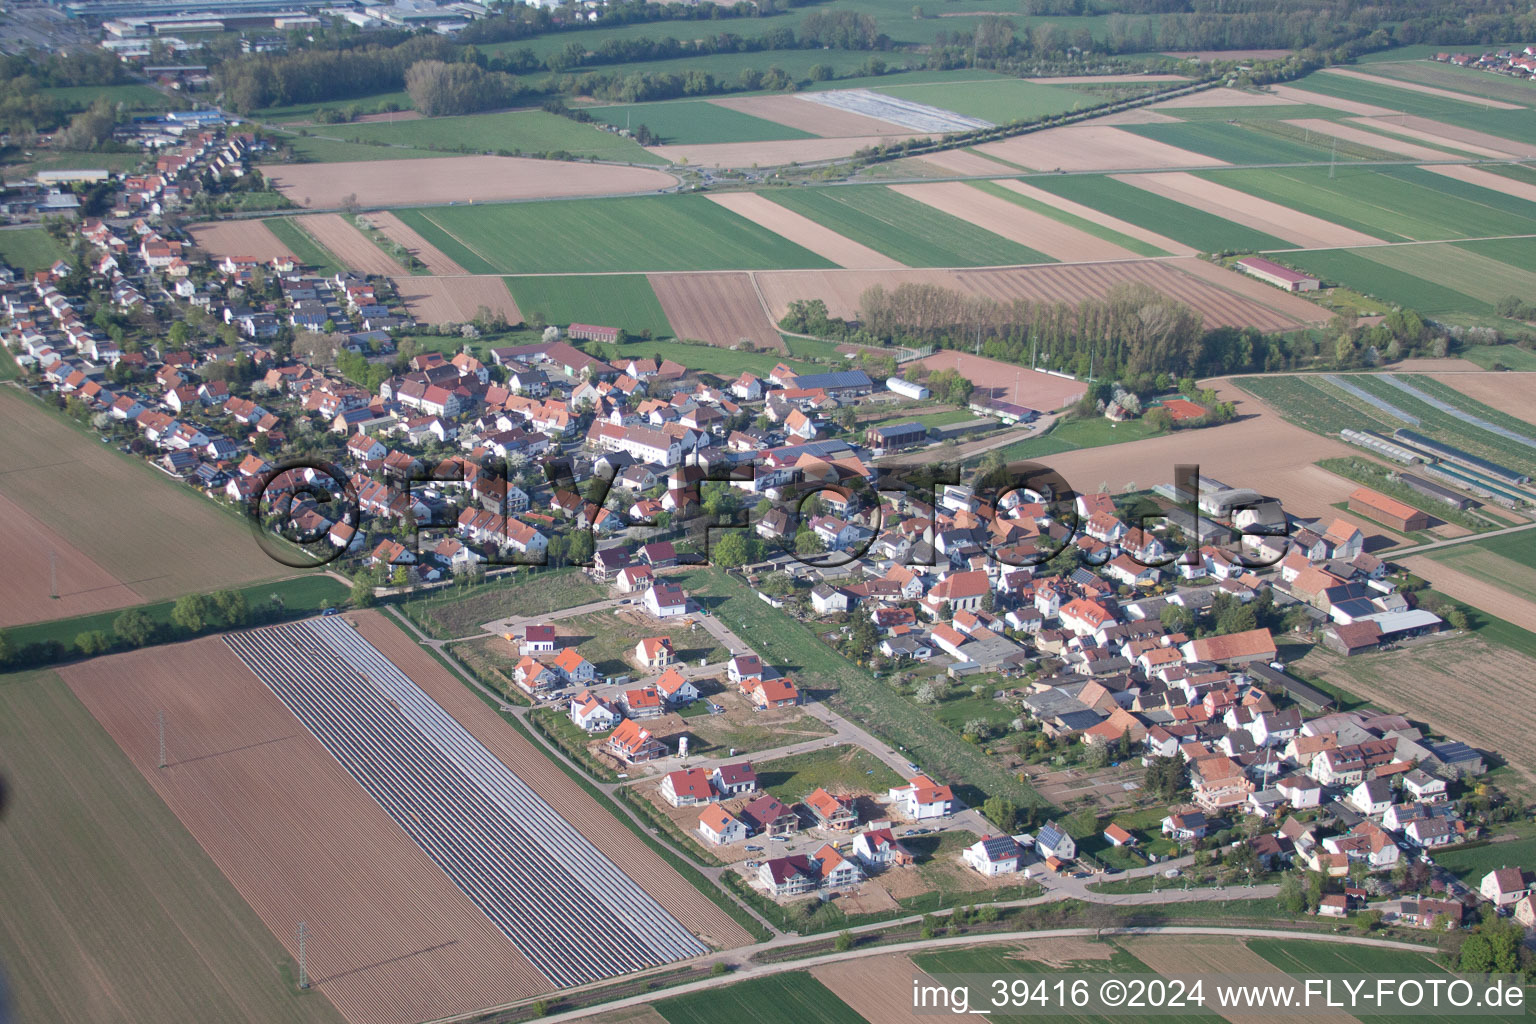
[1198,166,1536,241]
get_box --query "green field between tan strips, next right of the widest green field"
[763,184,1055,267]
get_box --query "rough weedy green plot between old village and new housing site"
[399,568,608,640]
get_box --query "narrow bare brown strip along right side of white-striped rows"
[350,613,753,949]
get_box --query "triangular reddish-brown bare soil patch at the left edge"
[0,494,144,626]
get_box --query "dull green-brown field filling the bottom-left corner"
[0,671,341,1024]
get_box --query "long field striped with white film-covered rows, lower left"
[224,619,708,987]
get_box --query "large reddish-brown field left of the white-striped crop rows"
[60,637,550,1024]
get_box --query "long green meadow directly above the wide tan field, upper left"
[299,107,666,164]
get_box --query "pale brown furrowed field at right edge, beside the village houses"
[1299,632,1536,778]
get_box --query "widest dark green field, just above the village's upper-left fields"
[390,195,833,275]
